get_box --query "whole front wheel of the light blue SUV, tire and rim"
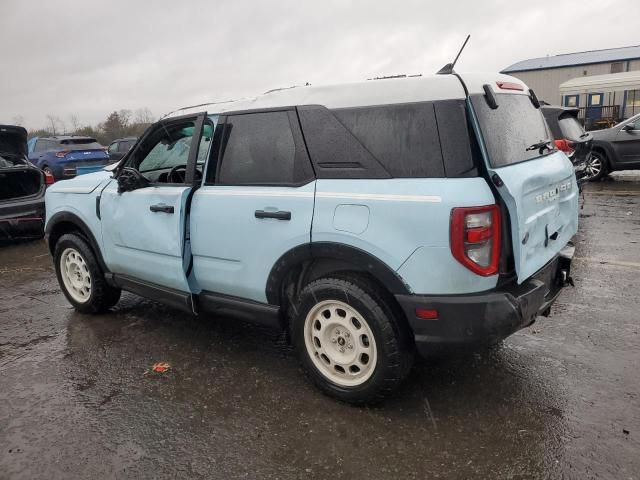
[54,234,120,313]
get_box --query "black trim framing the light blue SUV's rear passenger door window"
[209,106,316,187]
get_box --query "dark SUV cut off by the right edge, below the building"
[587,114,640,180]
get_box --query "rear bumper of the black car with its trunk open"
[0,195,45,240]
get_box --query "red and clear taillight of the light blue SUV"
[451,205,500,277]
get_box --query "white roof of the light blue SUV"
[169,73,528,116]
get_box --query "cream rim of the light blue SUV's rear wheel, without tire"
[304,300,378,387]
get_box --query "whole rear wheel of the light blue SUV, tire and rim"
[291,276,413,404]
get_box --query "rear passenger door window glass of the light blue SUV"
[217,111,312,185]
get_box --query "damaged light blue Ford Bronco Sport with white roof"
[46,74,578,403]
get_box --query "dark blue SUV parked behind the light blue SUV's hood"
[28,135,109,180]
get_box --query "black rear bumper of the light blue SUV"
[396,246,573,355]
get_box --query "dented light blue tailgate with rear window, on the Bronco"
[470,82,578,283]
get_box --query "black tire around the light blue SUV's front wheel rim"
[53,233,121,313]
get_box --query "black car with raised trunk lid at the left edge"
[0,125,46,240]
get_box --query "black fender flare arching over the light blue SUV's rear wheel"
[265,242,411,305]
